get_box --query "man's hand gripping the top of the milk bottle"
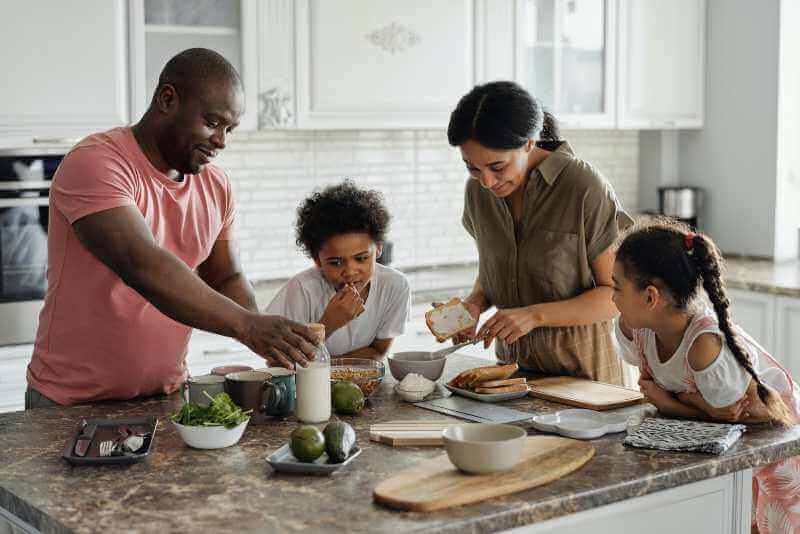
[237,313,316,369]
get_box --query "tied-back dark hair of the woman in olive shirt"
[447,82,560,150]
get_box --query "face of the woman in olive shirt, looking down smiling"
[459,139,535,198]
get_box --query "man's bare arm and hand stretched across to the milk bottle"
[73,206,314,367]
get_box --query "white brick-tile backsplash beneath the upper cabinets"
[217,130,639,281]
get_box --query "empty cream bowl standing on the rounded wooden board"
[442,423,528,475]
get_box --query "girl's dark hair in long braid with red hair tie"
[616,218,794,426]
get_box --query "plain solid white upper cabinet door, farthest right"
[618,0,706,129]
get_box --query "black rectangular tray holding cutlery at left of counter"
[61,415,158,465]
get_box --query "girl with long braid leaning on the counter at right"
[613,220,800,533]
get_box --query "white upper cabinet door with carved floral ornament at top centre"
[288,0,476,129]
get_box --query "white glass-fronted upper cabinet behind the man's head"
[129,0,258,130]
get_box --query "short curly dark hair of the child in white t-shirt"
[295,180,390,260]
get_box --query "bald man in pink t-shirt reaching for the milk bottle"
[25,49,314,408]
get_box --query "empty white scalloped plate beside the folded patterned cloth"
[533,409,631,439]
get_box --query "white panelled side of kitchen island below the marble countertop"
[506,469,752,534]
